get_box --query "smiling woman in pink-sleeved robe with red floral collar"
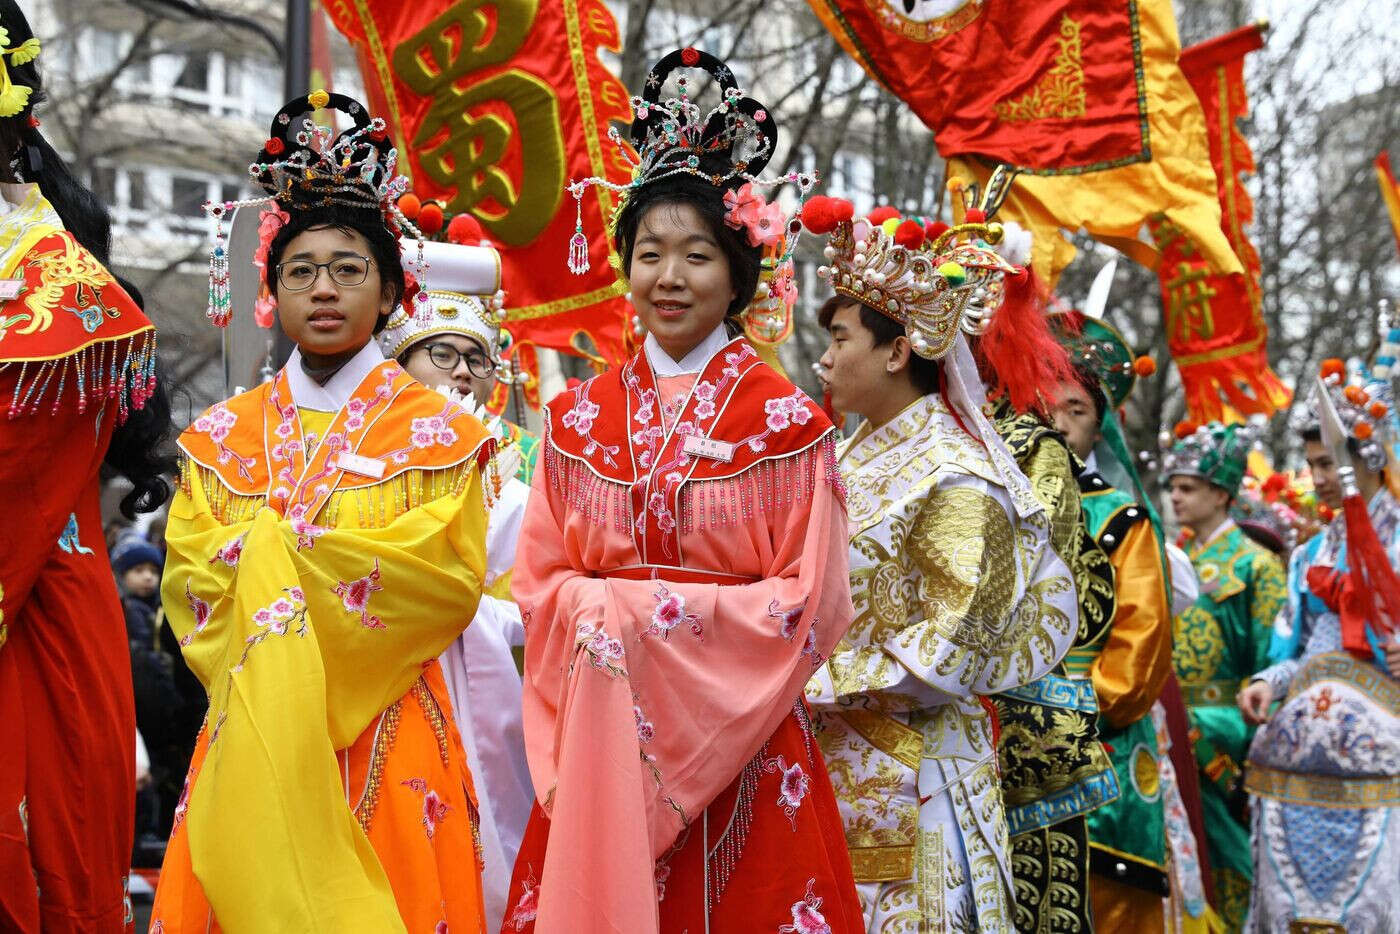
[503,49,861,934]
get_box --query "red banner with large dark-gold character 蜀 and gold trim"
[322,0,631,392]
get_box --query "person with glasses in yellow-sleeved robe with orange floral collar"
[151,92,494,934]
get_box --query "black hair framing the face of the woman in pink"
[613,160,763,323]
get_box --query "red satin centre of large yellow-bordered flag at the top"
[808,0,1152,175]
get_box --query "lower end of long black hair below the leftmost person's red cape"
[102,276,176,520]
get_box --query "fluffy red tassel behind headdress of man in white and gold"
[976,269,1075,412]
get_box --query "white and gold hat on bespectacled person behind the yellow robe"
[379,239,505,363]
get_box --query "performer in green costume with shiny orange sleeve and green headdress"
[1054,312,1172,931]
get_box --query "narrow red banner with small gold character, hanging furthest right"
[1149,25,1292,423]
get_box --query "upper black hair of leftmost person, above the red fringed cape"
[0,0,112,266]
